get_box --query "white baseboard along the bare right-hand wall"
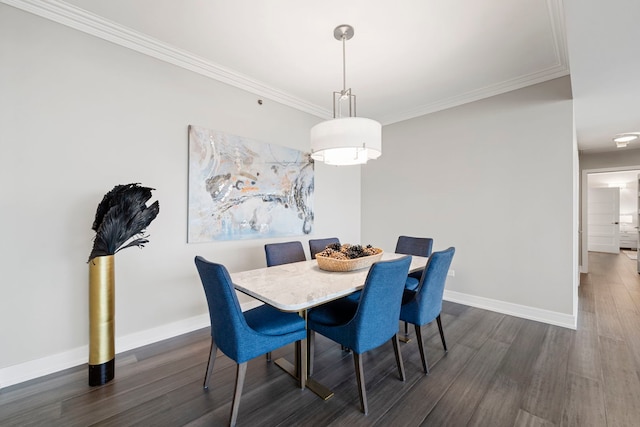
[444,289,578,329]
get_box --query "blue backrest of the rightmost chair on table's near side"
[402,247,456,325]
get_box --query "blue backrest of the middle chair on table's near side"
[343,256,411,353]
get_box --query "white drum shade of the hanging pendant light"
[311,117,382,166]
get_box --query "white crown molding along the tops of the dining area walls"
[0,0,569,125]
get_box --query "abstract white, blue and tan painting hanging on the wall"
[188,125,313,243]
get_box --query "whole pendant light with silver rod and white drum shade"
[311,25,382,166]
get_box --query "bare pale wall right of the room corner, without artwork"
[362,77,577,326]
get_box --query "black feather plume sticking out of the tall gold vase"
[89,183,160,261]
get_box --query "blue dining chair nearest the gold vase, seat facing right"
[195,256,306,426]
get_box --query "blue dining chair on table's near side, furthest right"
[400,247,456,374]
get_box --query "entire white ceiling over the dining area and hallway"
[7,0,640,152]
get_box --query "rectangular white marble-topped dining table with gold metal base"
[230,252,428,400]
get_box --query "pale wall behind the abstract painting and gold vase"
[0,4,360,387]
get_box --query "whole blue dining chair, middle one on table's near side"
[307,256,411,414]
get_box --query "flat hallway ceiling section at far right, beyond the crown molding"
[564,0,640,151]
